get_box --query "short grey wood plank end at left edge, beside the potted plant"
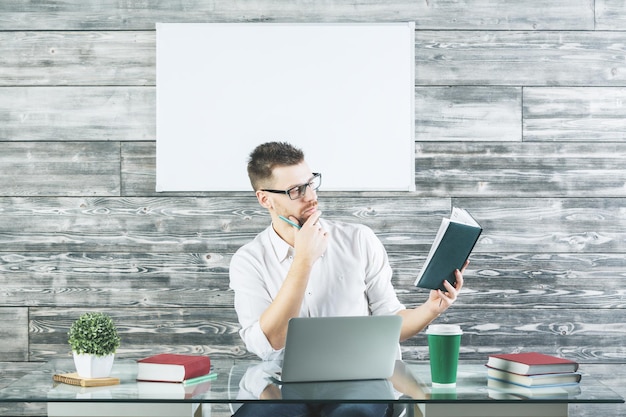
[0,303,29,361]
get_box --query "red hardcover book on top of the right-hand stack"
[487,352,578,375]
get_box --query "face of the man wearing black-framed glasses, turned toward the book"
[265,162,317,224]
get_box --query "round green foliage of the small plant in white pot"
[67,313,120,356]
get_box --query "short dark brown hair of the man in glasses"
[248,142,304,191]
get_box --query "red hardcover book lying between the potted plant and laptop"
[137,353,211,382]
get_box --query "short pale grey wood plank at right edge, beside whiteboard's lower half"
[524,87,626,141]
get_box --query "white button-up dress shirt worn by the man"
[230,220,405,360]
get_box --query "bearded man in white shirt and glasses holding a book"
[230,142,465,417]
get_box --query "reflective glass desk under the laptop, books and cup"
[0,359,624,417]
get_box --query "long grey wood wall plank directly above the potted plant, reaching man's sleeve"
[0,252,233,309]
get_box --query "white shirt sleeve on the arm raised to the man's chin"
[230,246,282,360]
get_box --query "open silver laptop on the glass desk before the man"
[273,315,402,383]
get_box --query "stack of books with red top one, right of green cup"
[487,352,582,397]
